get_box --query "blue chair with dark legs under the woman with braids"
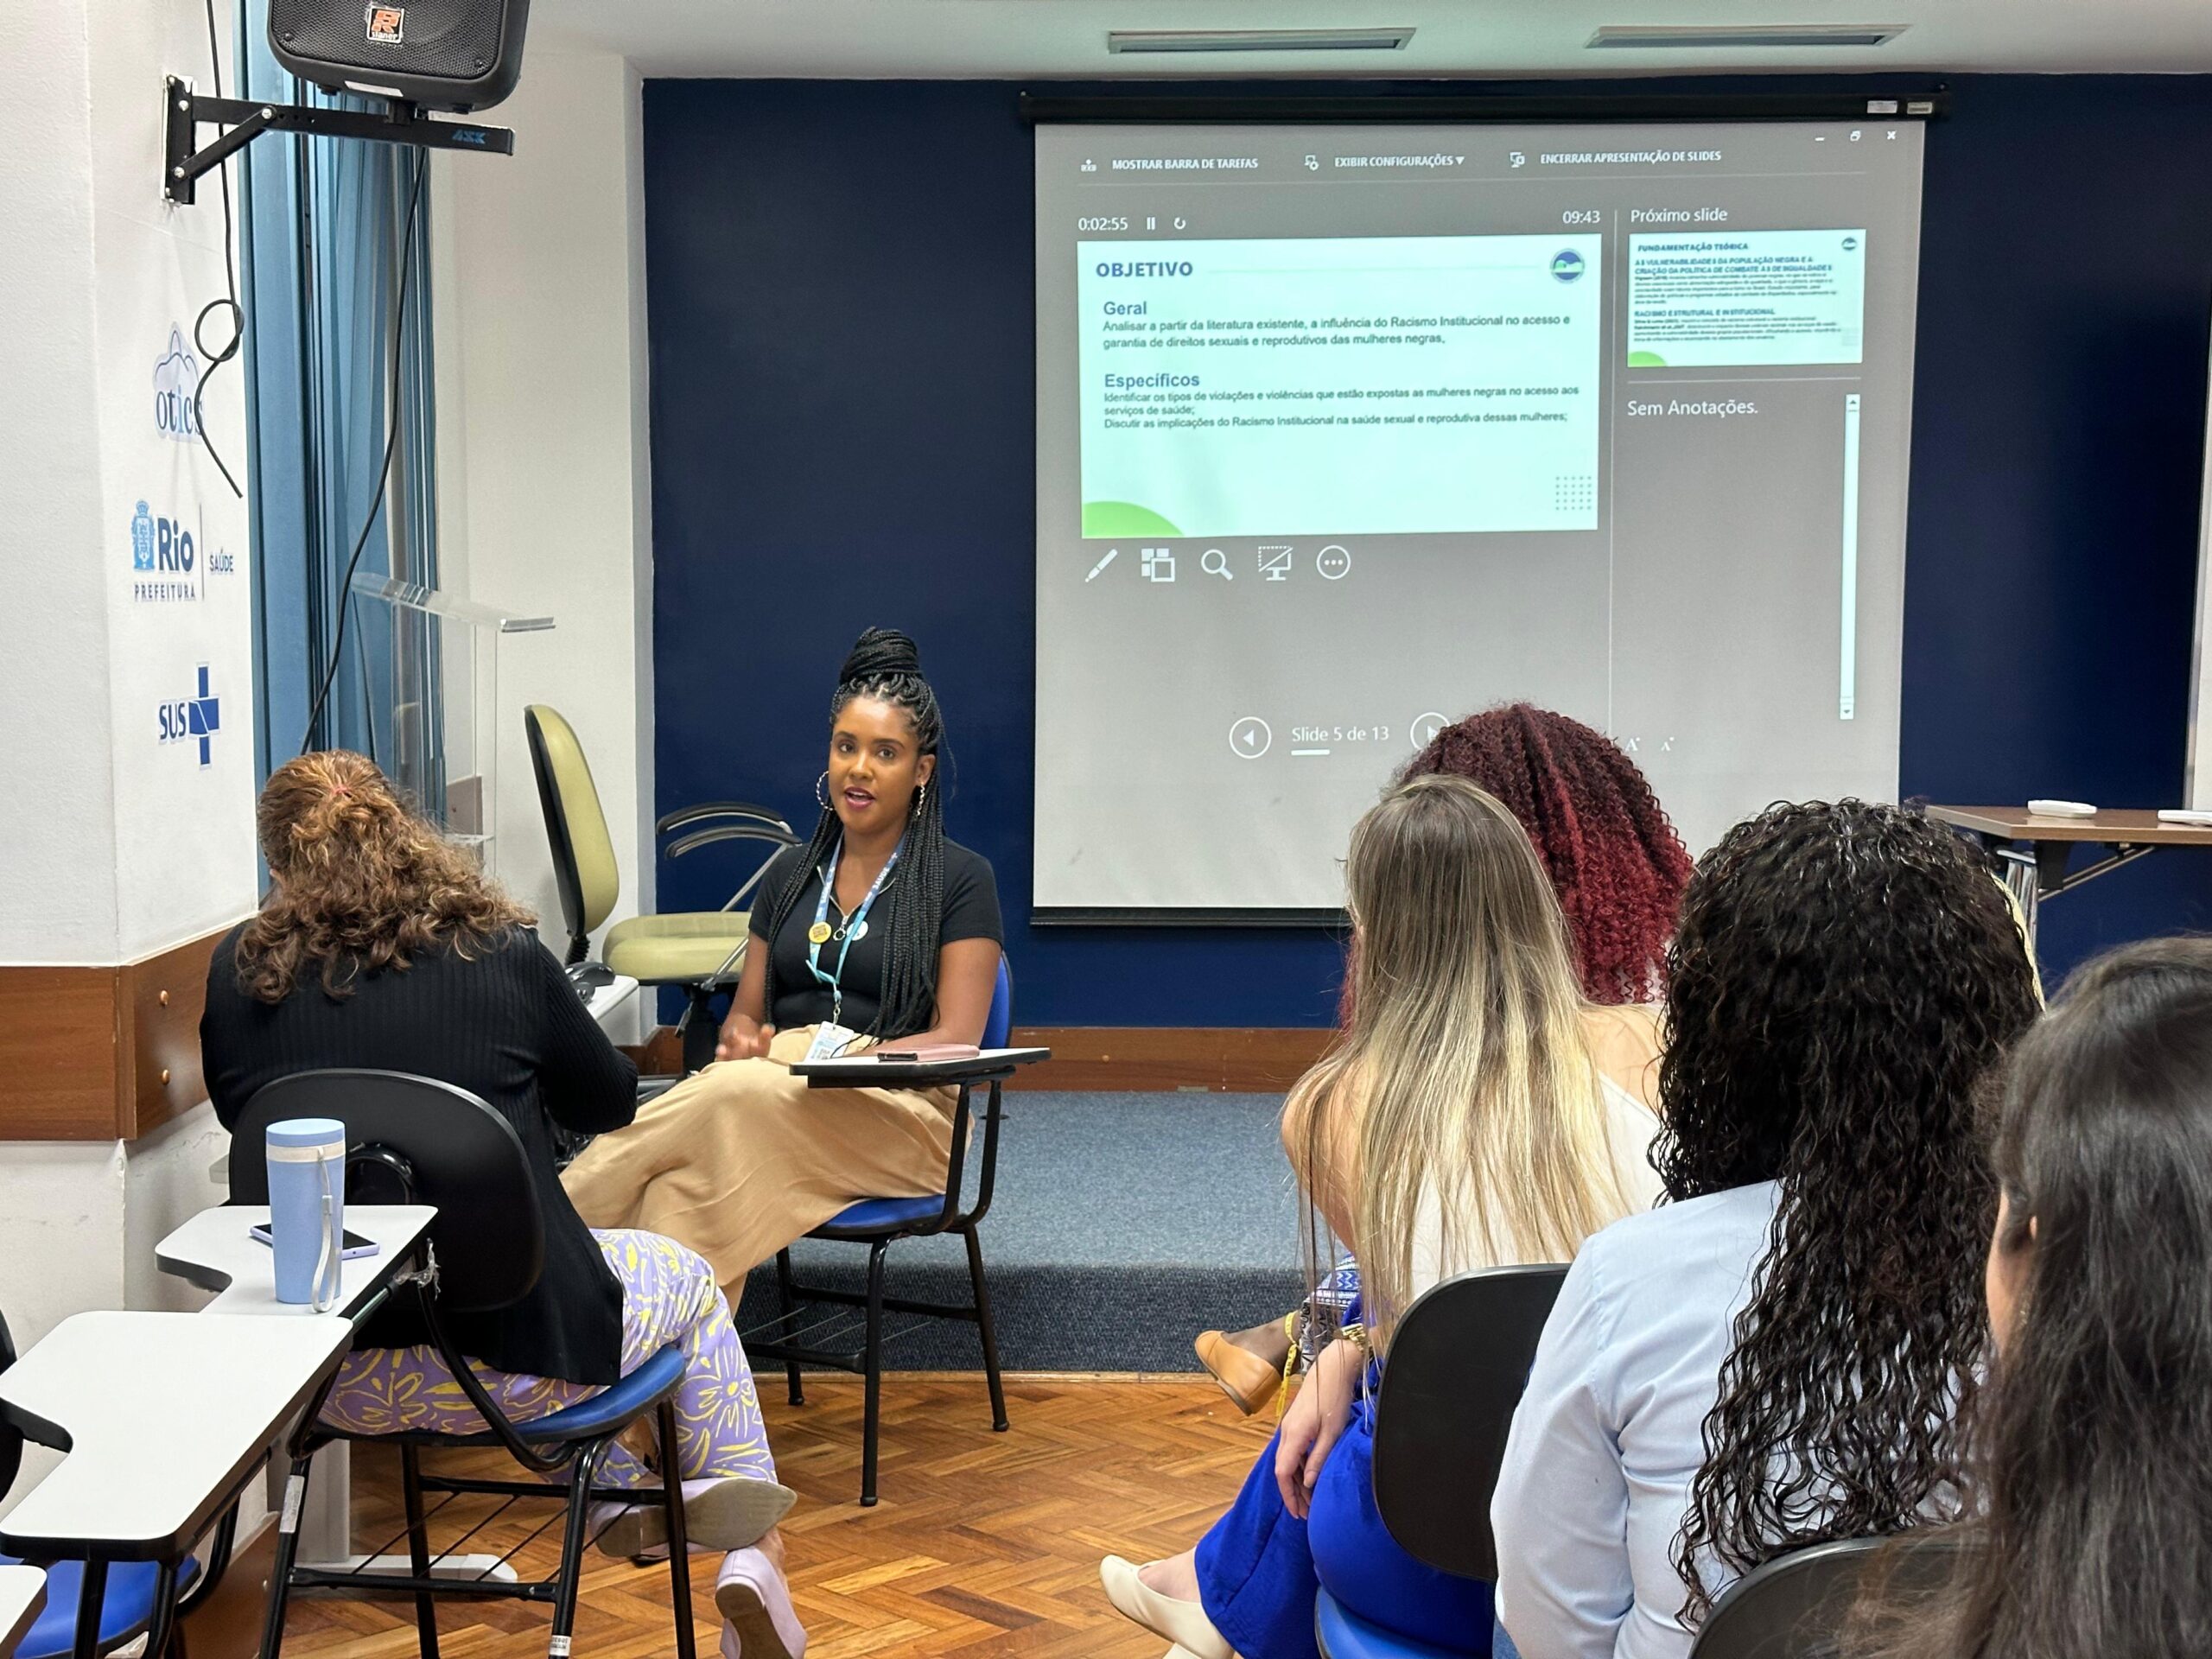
[746,956,1013,1509]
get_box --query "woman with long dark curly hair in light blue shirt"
[1491,801,2035,1659]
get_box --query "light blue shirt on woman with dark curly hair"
[1491,1181,1781,1659]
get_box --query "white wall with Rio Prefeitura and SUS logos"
[0,0,254,1491]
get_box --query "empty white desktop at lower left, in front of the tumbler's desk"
[0,1314,354,1561]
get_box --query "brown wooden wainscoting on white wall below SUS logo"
[0,927,230,1141]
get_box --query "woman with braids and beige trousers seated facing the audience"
[562,628,1000,1285]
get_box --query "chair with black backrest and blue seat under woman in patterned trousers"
[230,1071,695,1659]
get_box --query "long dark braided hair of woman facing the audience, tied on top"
[754,628,944,1039]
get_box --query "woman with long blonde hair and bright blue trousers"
[1102,777,1659,1659]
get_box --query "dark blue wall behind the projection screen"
[646,75,2212,1024]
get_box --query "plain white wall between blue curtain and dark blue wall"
[431,35,652,1039]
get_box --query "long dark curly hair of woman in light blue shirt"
[1652,801,2035,1624]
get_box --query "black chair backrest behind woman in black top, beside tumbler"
[230,1071,546,1312]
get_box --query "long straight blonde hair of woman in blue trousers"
[1285,774,1628,1340]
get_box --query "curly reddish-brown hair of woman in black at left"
[237,750,531,1002]
